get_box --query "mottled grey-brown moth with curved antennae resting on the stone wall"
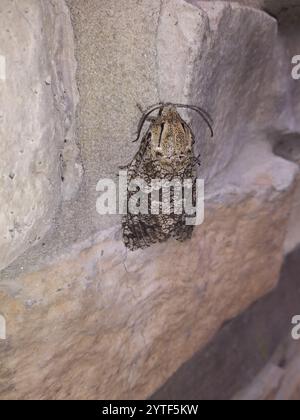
[122,103,213,251]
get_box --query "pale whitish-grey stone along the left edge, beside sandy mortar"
[0,0,79,270]
